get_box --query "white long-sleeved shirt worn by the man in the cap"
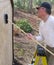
[36,15,54,47]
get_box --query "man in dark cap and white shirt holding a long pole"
[28,2,54,65]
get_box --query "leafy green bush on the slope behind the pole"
[16,19,33,33]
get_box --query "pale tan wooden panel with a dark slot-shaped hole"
[0,0,12,65]
